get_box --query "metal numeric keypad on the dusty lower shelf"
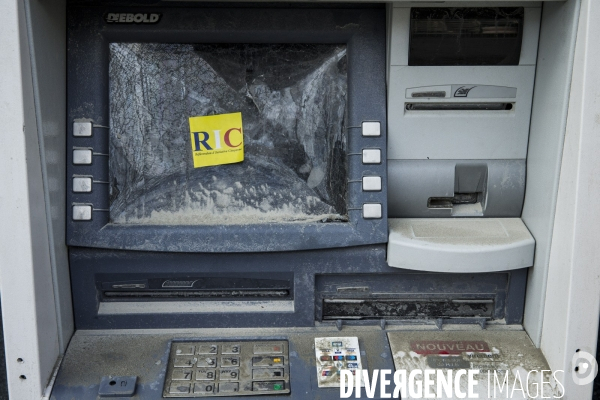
[163,341,290,398]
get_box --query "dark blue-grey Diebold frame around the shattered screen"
[67,4,387,252]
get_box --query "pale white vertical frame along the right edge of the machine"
[541,0,600,399]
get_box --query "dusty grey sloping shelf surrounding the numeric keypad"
[50,327,394,400]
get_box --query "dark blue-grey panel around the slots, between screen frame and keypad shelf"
[70,245,524,329]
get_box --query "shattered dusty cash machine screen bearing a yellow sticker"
[109,43,347,225]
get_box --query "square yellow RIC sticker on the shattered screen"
[190,113,244,168]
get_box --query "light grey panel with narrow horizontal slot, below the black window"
[388,66,535,160]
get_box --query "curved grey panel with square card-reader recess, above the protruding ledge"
[388,160,525,218]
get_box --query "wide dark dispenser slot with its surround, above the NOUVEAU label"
[316,271,511,324]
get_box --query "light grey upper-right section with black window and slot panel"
[388,3,541,160]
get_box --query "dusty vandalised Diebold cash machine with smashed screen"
[2,0,596,400]
